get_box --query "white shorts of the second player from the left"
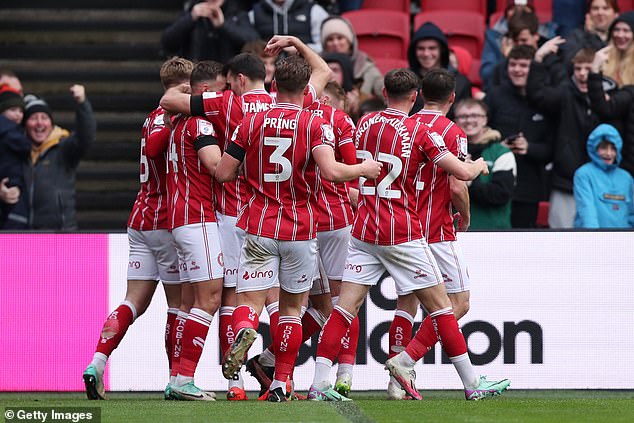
[172,222,224,282]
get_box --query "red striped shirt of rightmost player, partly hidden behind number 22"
[412,109,467,243]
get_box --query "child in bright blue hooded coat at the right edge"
[573,124,634,228]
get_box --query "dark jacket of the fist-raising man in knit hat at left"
[26,100,97,231]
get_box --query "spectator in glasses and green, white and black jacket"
[456,98,517,229]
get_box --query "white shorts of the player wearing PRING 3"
[236,234,317,294]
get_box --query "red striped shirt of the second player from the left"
[167,115,216,229]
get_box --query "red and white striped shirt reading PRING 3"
[234,103,335,241]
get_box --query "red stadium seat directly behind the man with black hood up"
[414,10,486,58]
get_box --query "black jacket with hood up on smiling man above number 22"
[407,22,471,119]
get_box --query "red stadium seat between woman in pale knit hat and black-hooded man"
[342,9,410,59]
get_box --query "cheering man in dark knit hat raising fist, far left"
[23,85,97,231]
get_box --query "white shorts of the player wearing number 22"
[343,238,443,295]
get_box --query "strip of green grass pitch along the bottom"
[0,390,634,423]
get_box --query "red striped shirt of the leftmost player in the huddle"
[128,107,170,231]
